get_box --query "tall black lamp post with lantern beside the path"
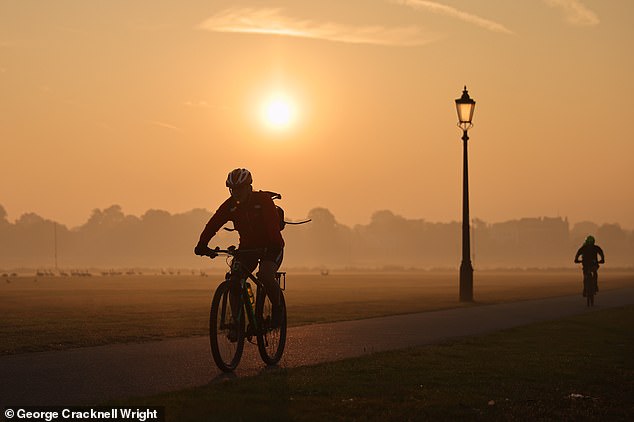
[456,86,475,302]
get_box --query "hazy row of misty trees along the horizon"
[0,205,634,269]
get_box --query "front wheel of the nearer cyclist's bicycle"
[209,281,244,372]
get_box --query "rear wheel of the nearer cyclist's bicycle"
[255,290,286,365]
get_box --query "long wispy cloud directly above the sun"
[199,8,438,46]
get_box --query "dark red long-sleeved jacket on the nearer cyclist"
[199,191,284,249]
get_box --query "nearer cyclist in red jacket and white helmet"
[194,168,284,332]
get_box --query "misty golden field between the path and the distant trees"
[0,271,634,355]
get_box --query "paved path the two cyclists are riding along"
[0,288,634,408]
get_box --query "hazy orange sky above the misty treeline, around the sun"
[0,0,634,229]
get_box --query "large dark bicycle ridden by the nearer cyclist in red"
[202,246,287,372]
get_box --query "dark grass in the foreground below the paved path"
[118,306,634,421]
